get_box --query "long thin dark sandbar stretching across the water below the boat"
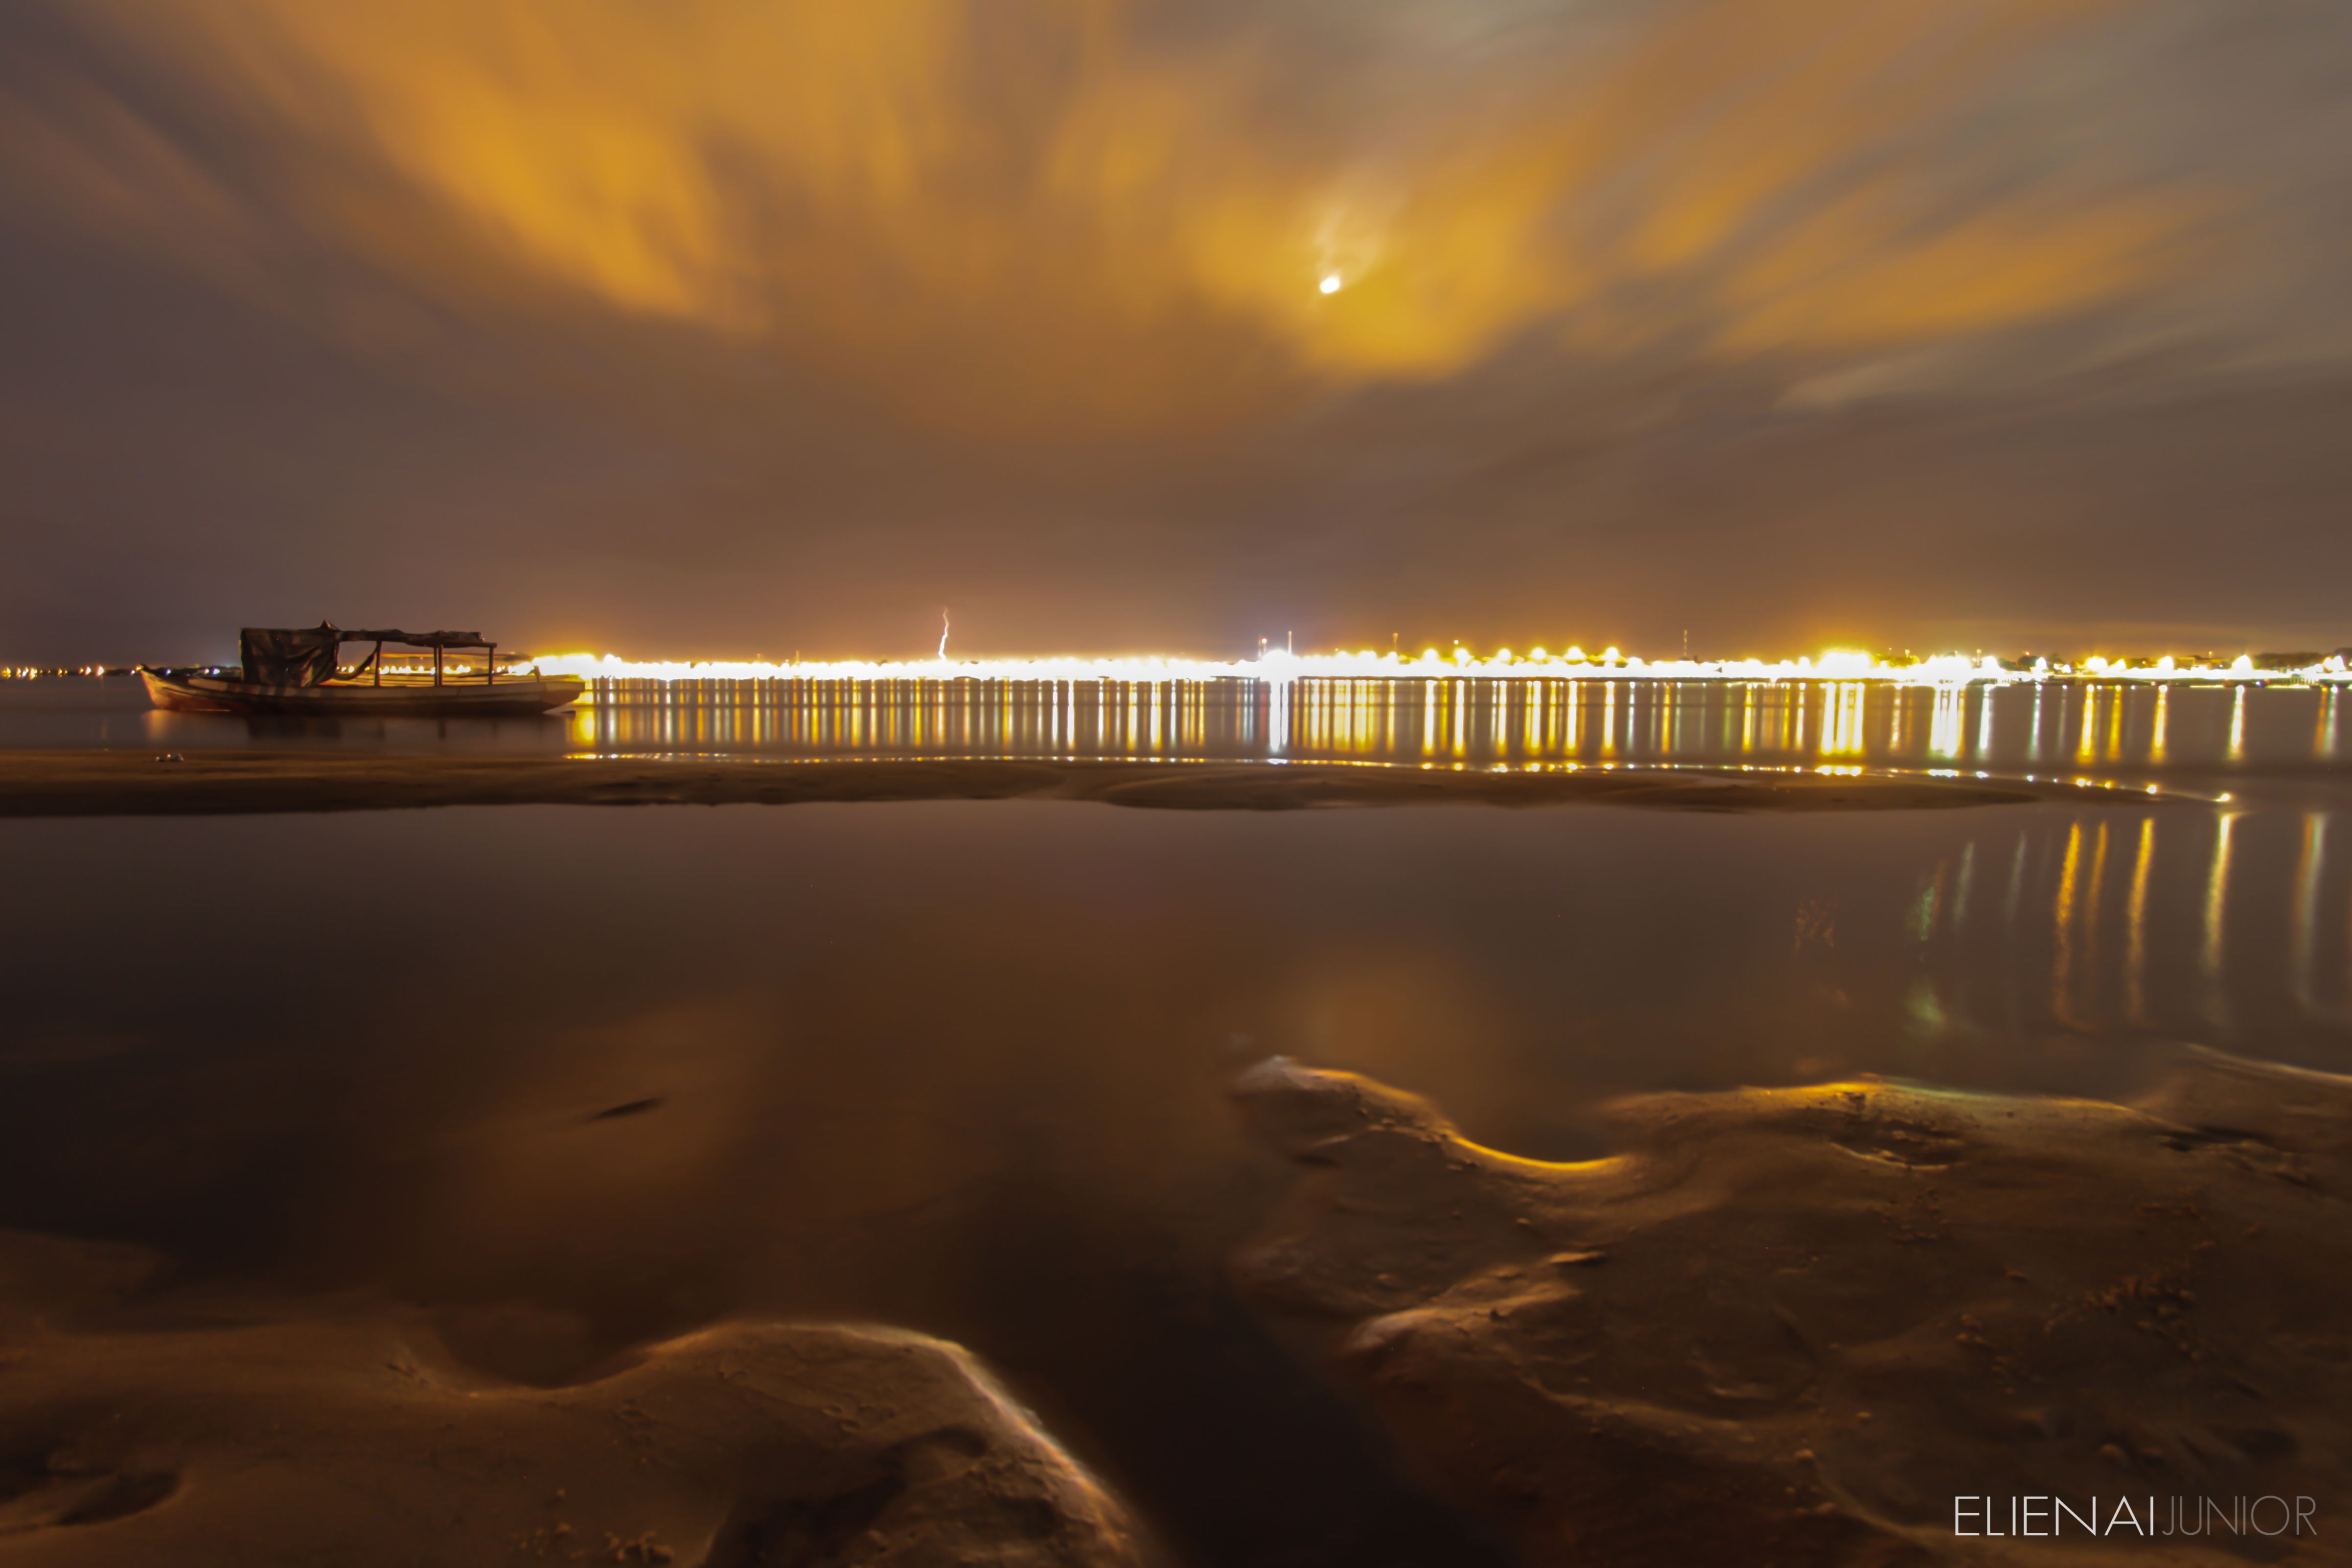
[0,750,2107,816]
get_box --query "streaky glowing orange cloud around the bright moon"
[59,0,2194,428]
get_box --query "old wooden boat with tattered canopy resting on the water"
[139,621,588,717]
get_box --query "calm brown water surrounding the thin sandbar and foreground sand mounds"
[0,682,2352,1568]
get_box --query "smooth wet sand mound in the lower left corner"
[0,1234,1143,1568]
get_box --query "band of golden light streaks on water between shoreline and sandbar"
[567,679,2343,773]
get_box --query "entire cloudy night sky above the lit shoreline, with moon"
[0,0,2352,661]
